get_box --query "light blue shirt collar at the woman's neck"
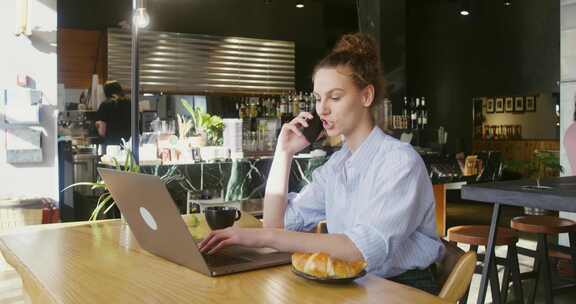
[338,126,386,172]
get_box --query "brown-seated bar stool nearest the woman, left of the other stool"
[448,225,524,303]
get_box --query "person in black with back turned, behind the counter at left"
[96,81,131,145]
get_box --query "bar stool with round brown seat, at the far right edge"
[510,215,576,303]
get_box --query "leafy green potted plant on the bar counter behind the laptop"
[180,99,224,145]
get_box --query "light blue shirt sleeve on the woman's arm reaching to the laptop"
[344,153,434,271]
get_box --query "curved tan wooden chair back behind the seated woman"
[436,240,476,302]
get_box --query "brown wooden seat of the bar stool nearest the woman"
[448,225,518,246]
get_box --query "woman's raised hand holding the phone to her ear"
[276,112,314,156]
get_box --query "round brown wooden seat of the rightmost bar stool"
[510,215,576,234]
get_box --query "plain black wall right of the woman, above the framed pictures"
[407,0,560,151]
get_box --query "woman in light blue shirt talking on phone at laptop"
[200,34,443,293]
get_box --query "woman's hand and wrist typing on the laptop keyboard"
[198,227,269,254]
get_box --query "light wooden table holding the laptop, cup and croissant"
[0,215,444,303]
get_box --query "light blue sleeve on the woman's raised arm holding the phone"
[284,164,326,231]
